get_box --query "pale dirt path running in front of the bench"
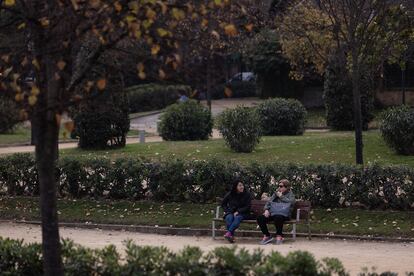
[0,223,414,275]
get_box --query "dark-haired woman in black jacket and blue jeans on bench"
[221,181,251,243]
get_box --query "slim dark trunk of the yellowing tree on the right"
[352,50,364,165]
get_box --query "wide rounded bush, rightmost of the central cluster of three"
[257,98,307,135]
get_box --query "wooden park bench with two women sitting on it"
[211,198,311,240]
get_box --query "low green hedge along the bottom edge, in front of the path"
[0,237,366,276]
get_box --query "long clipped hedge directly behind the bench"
[0,154,414,209]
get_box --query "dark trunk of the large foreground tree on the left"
[34,56,63,276]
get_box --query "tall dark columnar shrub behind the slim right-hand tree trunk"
[323,61,374,130]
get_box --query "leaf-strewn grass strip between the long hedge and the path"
[0,197,414,238]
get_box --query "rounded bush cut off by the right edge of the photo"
[380,106,414,155]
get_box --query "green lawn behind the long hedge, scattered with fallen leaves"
[60,130,414,166]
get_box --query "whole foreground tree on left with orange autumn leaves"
[0,0,252,275]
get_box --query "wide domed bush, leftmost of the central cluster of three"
[158,101,213,141]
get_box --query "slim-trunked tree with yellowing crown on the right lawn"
[281,0,407,164]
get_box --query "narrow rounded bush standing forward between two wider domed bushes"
[218,106,261,152]
